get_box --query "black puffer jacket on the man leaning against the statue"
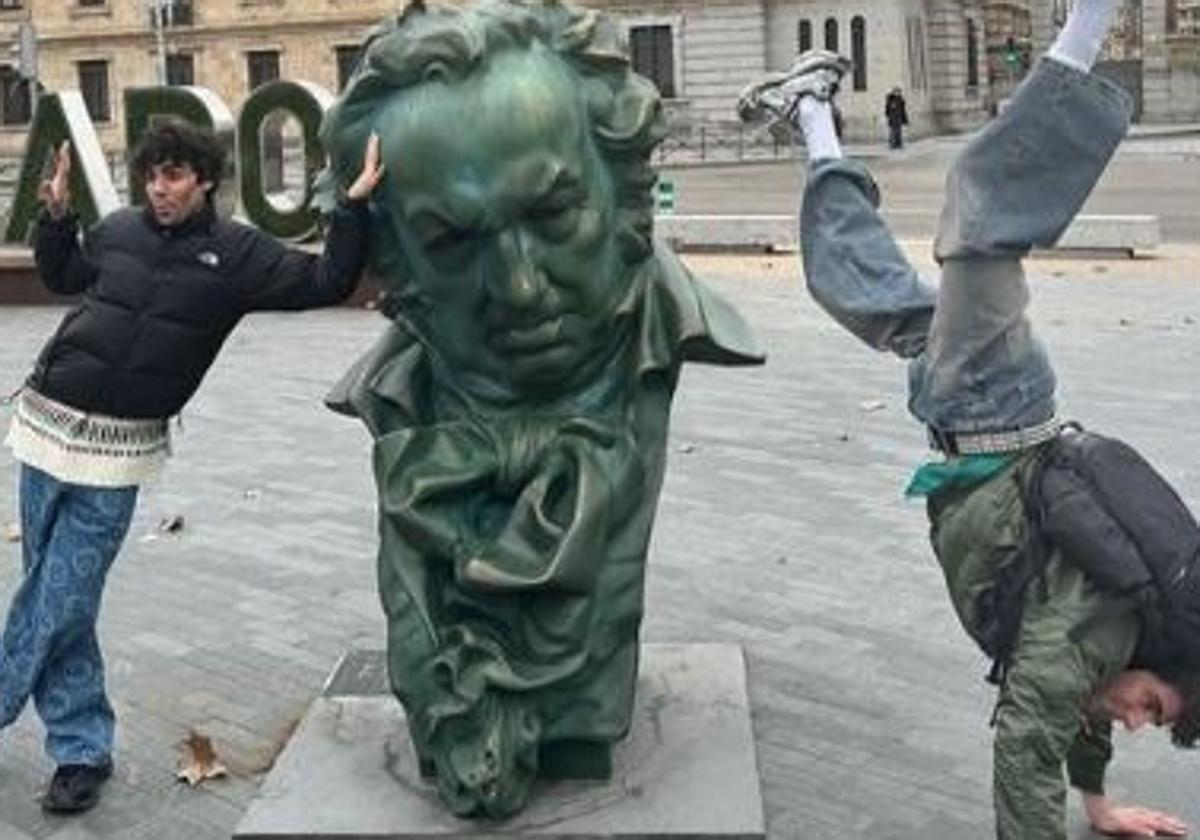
[29,202,368,418]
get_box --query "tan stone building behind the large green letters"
[0,0,396,155]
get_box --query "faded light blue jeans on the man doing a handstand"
[800,60,1130,433]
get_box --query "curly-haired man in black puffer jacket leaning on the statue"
[0,120,382,812]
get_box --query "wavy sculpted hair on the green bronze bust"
[316,0,666,289]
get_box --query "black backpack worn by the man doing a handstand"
[980,430,1200,683]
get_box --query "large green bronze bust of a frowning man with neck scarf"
[319,0,762,817]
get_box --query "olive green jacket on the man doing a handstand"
[929,450,1140,840]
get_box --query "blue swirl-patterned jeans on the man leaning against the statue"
[0,464,138,766]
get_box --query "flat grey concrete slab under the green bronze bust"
[234,644,766,840]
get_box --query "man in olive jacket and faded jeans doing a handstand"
[739,0,1200,840]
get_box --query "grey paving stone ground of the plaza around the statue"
[7,245,1200,840]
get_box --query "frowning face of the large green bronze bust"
[379,48,631,401]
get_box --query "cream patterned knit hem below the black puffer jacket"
[5,388,170,487]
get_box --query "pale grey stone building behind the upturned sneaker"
[576,0,989,140]
